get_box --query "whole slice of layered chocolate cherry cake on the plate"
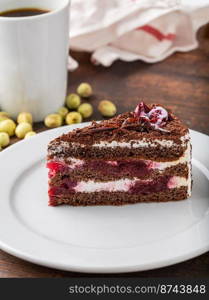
[47,102,191,206]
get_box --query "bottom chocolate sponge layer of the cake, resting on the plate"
[49,187,188,206]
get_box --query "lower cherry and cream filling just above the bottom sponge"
[49,176,176,196]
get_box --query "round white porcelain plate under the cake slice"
[0,124,209,273]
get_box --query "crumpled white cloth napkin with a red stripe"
[69,0,209,70]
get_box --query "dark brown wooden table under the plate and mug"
[0,25,209,278]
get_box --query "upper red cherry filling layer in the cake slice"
[47,160,159,178]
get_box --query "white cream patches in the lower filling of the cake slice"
[74,176,188,193]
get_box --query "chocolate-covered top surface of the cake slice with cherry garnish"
[52,102,188,145]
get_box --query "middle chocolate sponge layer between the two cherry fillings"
[50,163,189,186]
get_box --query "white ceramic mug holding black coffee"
[0,0,70,121]
